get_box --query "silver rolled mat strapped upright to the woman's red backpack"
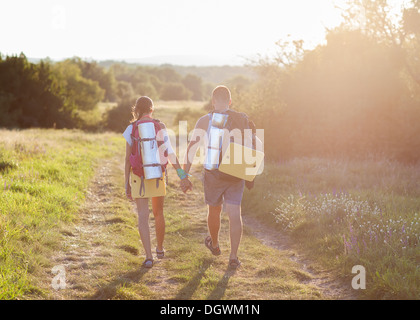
[138,122,162,179]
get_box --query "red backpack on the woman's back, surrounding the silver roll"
[130,118,168,178]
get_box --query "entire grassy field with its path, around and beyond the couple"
[0,103,420,299]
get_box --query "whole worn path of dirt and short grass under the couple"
[43,158,354,300]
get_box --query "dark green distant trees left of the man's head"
[0,53,248,130]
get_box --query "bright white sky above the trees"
[0,0,348,64]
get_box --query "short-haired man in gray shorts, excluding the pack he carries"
[184,86,252,268]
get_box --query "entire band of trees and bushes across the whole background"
[0,0,420,163]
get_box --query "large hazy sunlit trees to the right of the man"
[233,0,420,163]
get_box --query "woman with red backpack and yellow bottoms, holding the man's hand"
[123,96,192,268]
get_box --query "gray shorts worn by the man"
[204,170,245,207]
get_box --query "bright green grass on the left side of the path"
[0,130,120,299]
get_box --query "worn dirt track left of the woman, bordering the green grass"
[46,159,115,300]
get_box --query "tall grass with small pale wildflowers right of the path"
[243,159,420,299]
